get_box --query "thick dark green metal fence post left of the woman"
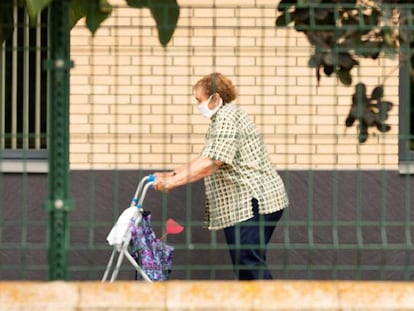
[45,0,73,280]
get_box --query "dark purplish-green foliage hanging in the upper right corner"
[276,0,414,143]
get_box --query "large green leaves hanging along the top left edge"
[0,0,180,47]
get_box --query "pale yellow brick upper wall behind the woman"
[70,0,398,169]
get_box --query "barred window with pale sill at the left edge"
[0,7,48,172]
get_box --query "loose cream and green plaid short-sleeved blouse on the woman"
[201,104,289,230]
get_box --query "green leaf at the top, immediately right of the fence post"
[69,0,112,34]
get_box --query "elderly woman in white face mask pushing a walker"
[154,73,288,280]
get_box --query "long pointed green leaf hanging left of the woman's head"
[126,0,180,47]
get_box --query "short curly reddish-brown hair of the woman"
[193,72,237,104]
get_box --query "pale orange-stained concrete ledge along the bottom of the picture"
[0,281,414,311]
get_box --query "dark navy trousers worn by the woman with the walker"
[224,198,283,280]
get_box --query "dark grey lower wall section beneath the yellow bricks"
[0,170,414,280]
